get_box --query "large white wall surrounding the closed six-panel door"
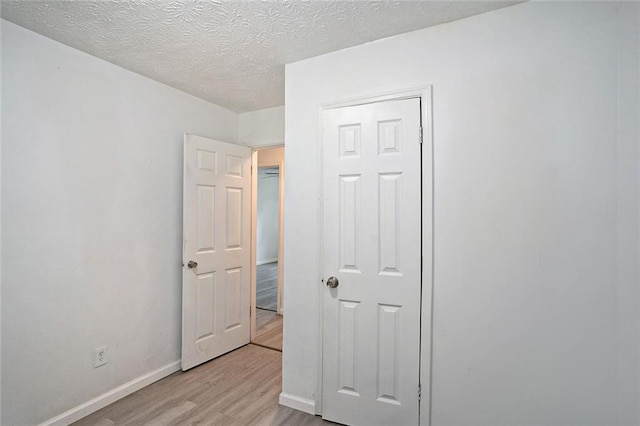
[283,2,640,425]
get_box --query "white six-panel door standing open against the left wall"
[182,134,251,370]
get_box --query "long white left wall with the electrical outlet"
[2,21,238,425]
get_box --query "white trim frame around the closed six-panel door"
[315,85,434,426]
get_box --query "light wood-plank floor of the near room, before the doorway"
[74,345,334,426]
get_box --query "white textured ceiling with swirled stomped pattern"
[0,0,517,112]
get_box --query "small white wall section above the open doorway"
[238,106,284,147]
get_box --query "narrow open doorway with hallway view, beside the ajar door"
[251,147,284,351]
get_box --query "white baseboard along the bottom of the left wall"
[40,361,180,426]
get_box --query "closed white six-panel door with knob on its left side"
[322,98,421,425]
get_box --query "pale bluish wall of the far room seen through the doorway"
[256,166,280,265]
